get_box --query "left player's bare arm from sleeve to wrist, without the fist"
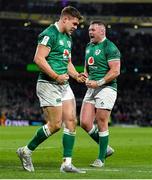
[34,44,58,79]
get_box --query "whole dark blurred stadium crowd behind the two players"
[0,0,152,126]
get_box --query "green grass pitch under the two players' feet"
[0,127,152,179]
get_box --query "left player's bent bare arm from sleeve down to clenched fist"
[34,44,69,84]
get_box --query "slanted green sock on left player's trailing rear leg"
[27,125,51,151]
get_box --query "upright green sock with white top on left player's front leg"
[63,128,75,157]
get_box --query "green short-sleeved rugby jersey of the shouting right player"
[85,38,120,89]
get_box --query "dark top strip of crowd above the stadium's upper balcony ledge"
[0,0,152,16]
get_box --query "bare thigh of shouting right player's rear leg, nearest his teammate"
[80,102,95,131]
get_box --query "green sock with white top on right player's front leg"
[98,130,109,163]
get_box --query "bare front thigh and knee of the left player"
[62,99,77,131]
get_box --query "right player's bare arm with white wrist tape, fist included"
[86,59,120,89]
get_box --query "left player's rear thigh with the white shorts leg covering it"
[36,82,63,129]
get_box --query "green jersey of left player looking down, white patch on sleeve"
[38,23,72,81]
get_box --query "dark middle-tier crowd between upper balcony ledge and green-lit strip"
[0,23,152,73]
